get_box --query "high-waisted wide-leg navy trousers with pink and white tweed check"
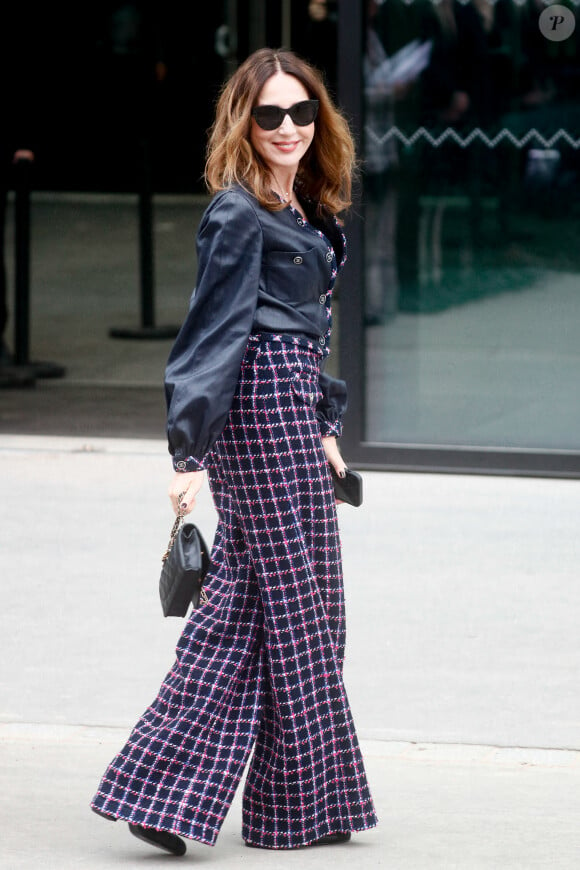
[92,336,376,849]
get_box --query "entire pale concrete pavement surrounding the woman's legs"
[0,435,580,870]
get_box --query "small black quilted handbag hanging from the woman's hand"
[159,516,209,616]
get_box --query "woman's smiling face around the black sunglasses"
[250,72,314,175]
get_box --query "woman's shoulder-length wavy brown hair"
[205,48,356,214]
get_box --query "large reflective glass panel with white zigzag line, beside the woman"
[364,0,580,449]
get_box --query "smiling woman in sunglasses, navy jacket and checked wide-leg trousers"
[92,49,376,854]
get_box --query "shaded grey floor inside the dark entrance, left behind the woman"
[0,193,206,438]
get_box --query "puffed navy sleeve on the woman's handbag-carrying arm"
[165,190,263,471]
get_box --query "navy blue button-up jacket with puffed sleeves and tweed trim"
[165,187,346,471]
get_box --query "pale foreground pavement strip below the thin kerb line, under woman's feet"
[0,726,580,870]
